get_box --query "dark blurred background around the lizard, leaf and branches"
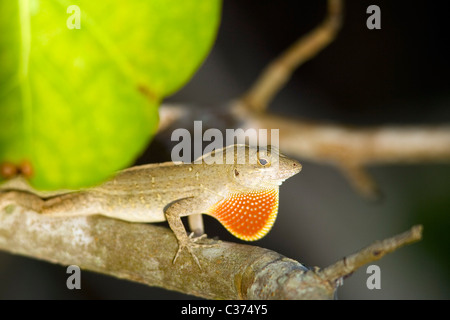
[0,0,450,299]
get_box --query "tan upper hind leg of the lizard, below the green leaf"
[41,192,101,217]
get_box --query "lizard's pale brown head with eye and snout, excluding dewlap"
[231,145,302,189]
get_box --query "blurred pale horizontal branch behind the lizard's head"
[232,105,450,166]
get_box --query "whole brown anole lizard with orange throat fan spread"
[0,145,302,264]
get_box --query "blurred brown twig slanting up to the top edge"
[240,0,343,112]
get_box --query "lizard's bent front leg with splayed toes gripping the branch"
[164,197,220,269]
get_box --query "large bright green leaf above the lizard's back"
[0,0,221,189]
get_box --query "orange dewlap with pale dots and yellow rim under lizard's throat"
[207,188,278,241]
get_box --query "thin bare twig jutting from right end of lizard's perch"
[319,225,423,282]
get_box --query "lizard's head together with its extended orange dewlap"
[207,145,302,241]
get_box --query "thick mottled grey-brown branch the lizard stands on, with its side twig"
[0,202,420,299]
